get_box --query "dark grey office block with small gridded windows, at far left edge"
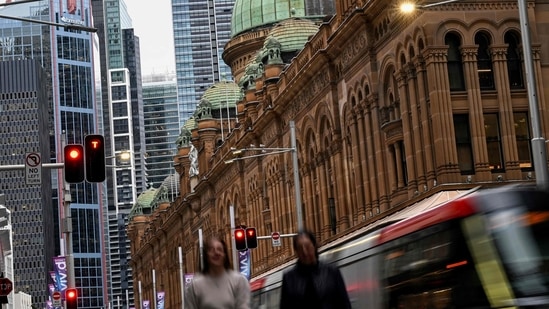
[0,59,53,304]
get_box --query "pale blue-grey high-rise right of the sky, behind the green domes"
[172,0,234,127]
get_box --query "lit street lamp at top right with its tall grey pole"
[400,0,549,189]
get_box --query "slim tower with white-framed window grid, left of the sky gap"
[92,0,147,307]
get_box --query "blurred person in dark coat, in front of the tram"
[280,231,351,309]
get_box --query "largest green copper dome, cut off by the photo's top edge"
[231,0,335,37]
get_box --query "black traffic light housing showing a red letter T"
[84,134,106,182]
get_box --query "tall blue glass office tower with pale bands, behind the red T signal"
[0,0,106,308]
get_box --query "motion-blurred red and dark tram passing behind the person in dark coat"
[251,186,549,309]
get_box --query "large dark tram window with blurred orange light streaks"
[383,223,488,309]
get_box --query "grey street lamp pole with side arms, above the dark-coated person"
[225,120,303,231]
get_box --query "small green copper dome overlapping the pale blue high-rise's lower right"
[202,80,242,110]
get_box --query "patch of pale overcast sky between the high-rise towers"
[125,0,175,75]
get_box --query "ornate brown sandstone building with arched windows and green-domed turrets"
[128,0,549,308]
